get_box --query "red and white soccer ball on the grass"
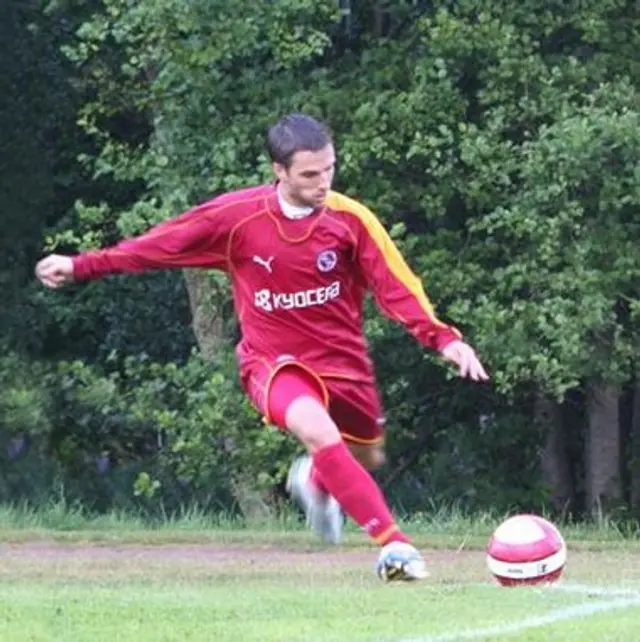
[487,515,567,586]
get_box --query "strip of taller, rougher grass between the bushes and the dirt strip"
[0,500,640,550]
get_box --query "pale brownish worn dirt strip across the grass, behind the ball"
[0,540,640,585]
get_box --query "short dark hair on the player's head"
[267,113,333,168]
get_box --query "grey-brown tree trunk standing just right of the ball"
[585,382,622,520]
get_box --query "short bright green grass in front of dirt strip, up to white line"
[0,575,592,642]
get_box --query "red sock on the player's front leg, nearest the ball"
[313,442,409,546]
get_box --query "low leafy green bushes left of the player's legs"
[0,344,295,512]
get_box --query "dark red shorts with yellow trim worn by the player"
[242,360,384,444]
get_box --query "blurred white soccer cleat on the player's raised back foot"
[287,456,343,544]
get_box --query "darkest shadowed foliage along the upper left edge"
[0,0,74,339]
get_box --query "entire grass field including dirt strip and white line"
[0,510,640,642]
